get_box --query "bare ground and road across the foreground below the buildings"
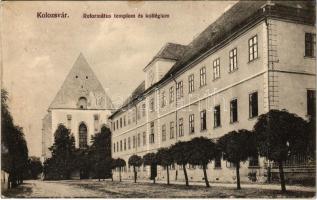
[3,180,315,198]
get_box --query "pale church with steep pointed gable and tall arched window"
[42,54,113,160]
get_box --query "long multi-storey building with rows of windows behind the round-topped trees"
[109,1,316,182]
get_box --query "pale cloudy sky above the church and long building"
[0,1,236,156]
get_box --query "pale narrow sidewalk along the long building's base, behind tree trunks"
[122,179,316,192]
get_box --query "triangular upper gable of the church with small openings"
[49,54,113,109]
